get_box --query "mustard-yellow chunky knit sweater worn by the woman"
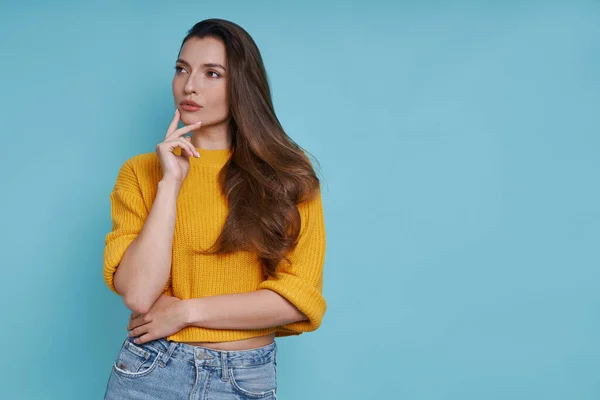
[104,148,327,342]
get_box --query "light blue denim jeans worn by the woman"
[104,337,277,400]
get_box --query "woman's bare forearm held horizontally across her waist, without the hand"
[184,289,307,329]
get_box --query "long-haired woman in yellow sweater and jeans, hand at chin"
[104,19,326,399]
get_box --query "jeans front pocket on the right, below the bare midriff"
[229,361,277,399]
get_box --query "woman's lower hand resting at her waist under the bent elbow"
[127,294,186,344]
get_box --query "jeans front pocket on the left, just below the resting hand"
[113,338,162,378]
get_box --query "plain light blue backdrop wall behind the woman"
[0,0,600,400]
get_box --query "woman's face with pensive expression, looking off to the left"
[173,37,229,129]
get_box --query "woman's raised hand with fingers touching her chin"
[156,109,202,184]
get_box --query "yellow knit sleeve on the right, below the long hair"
[258,189,327,334]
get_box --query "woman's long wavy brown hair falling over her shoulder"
[180,18,320,276]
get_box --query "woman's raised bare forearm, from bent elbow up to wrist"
[114,179,181,314]
